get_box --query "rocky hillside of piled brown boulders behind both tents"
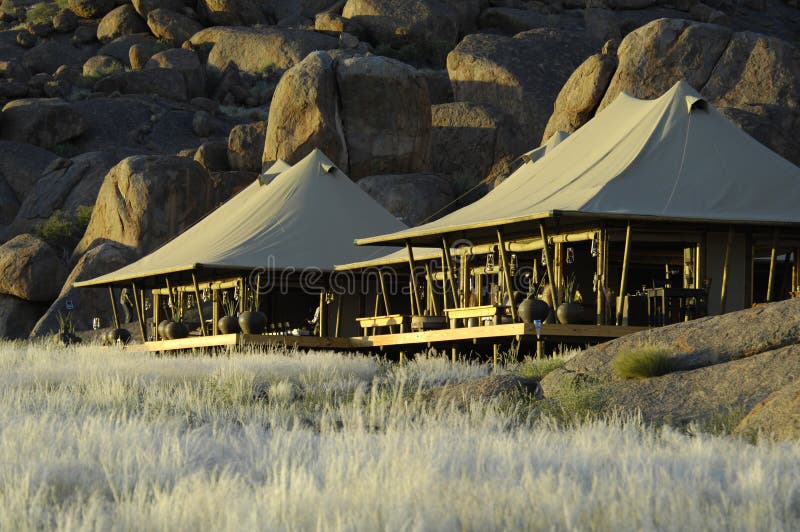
[0,0,800,337]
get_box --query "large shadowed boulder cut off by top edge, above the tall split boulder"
[342,0,460,49]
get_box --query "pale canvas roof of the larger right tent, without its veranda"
[358,81,800,245]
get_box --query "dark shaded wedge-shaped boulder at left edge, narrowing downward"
[0,141,58,205]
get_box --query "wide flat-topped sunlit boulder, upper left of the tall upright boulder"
[203,27,339,78]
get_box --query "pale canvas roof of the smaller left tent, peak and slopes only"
[75,150,406,286]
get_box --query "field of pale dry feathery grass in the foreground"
[0,343,800,531]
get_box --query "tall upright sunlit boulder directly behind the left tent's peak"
[262,52,348,171]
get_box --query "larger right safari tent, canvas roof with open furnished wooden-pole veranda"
[348,78,800,344]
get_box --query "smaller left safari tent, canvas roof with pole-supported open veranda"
[75,150,406,339]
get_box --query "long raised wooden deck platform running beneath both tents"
[144,323,647,352]
